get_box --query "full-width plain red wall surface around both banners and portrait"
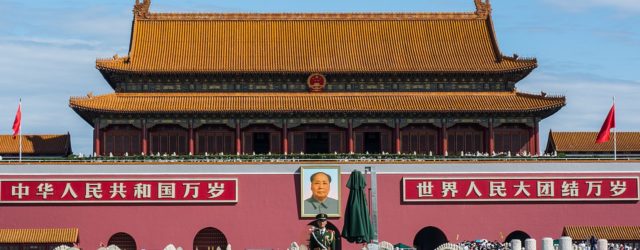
[0,173,640,249]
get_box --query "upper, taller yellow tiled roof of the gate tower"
[96,0,537,73]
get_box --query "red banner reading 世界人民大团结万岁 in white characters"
[402,177,639,202]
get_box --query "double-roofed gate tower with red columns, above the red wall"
[70,1,565,155]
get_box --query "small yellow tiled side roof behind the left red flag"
[0,134,71,155]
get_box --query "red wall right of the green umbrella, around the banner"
[378,173,640,245]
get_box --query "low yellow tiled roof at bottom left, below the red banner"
[0,228,78,244]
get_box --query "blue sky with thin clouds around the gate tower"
[0,0,640,154]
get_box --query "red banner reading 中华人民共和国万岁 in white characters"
[0,178,238,203]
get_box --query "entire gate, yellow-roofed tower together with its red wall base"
[6,0,640,250]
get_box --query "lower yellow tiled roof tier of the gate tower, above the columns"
[70,92,565,113]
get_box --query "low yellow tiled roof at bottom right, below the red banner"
[562,226,640,241]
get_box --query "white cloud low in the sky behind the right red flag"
[517,72,640,150]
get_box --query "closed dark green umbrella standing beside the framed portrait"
[342,170,373,243]
